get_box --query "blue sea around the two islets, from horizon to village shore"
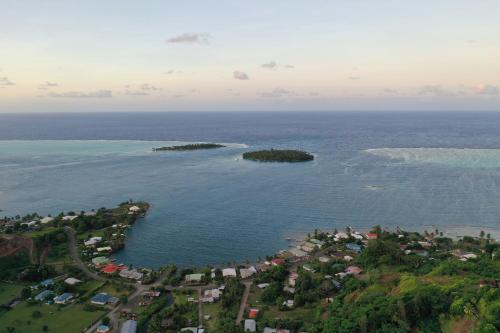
[0,112,500,266]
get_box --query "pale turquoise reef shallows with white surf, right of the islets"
[365,148,500,168]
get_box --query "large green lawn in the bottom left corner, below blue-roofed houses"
[0,302,104,333]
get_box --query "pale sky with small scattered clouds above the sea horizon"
[0,0,500,113]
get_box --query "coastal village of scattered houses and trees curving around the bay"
[0,202,498,333]
